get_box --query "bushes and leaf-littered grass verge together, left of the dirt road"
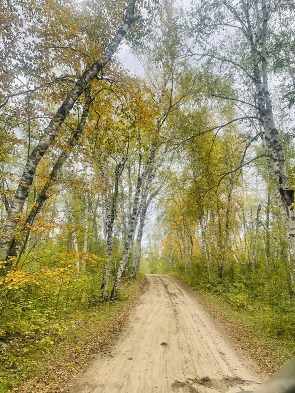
[0,271,144,393]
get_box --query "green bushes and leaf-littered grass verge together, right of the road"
[146,239,295,374]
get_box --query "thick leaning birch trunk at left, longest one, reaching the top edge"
[0,0,136,276]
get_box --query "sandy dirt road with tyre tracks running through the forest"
[70,275,259,393]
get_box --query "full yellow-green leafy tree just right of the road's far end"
[161,124,243,281]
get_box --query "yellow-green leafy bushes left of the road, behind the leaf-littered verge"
[0,245,106,392]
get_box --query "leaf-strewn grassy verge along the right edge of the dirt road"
[176,276,295,374]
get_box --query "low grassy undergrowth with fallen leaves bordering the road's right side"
[177,273,295,373]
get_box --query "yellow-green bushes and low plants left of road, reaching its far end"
[0,245,145,393]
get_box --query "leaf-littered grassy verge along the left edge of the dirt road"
[0,277,144,393]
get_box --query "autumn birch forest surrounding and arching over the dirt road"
[0,0,295,392]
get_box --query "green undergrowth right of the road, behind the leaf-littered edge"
[174,250,295,343]
